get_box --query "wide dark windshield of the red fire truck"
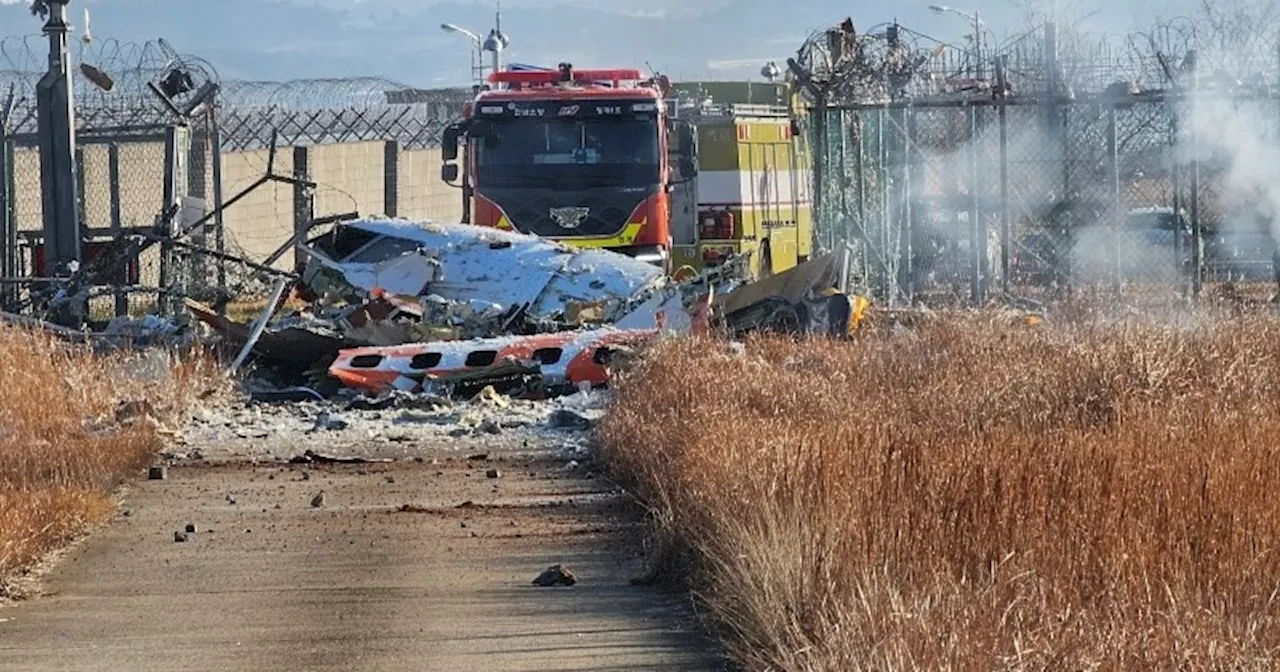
[476,116,660,189]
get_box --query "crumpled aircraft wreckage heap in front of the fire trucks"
[188,219,867,397]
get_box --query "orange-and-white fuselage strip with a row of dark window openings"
[329,329,658,394]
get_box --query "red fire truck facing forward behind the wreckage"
[442,64,696,268]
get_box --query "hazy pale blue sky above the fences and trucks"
[0,0,1197,86]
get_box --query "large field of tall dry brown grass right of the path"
[602,315,1280,671]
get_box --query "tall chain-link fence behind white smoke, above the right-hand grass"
[810,95,1280,301]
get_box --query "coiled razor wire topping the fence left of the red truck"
[0,36,471,151]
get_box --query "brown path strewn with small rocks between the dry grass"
[0,437,722,672]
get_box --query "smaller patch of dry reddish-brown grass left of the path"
[0,328,216,596]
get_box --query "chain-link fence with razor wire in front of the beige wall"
[0,37,468,322]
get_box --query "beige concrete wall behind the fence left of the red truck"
[3,137,462,273]
